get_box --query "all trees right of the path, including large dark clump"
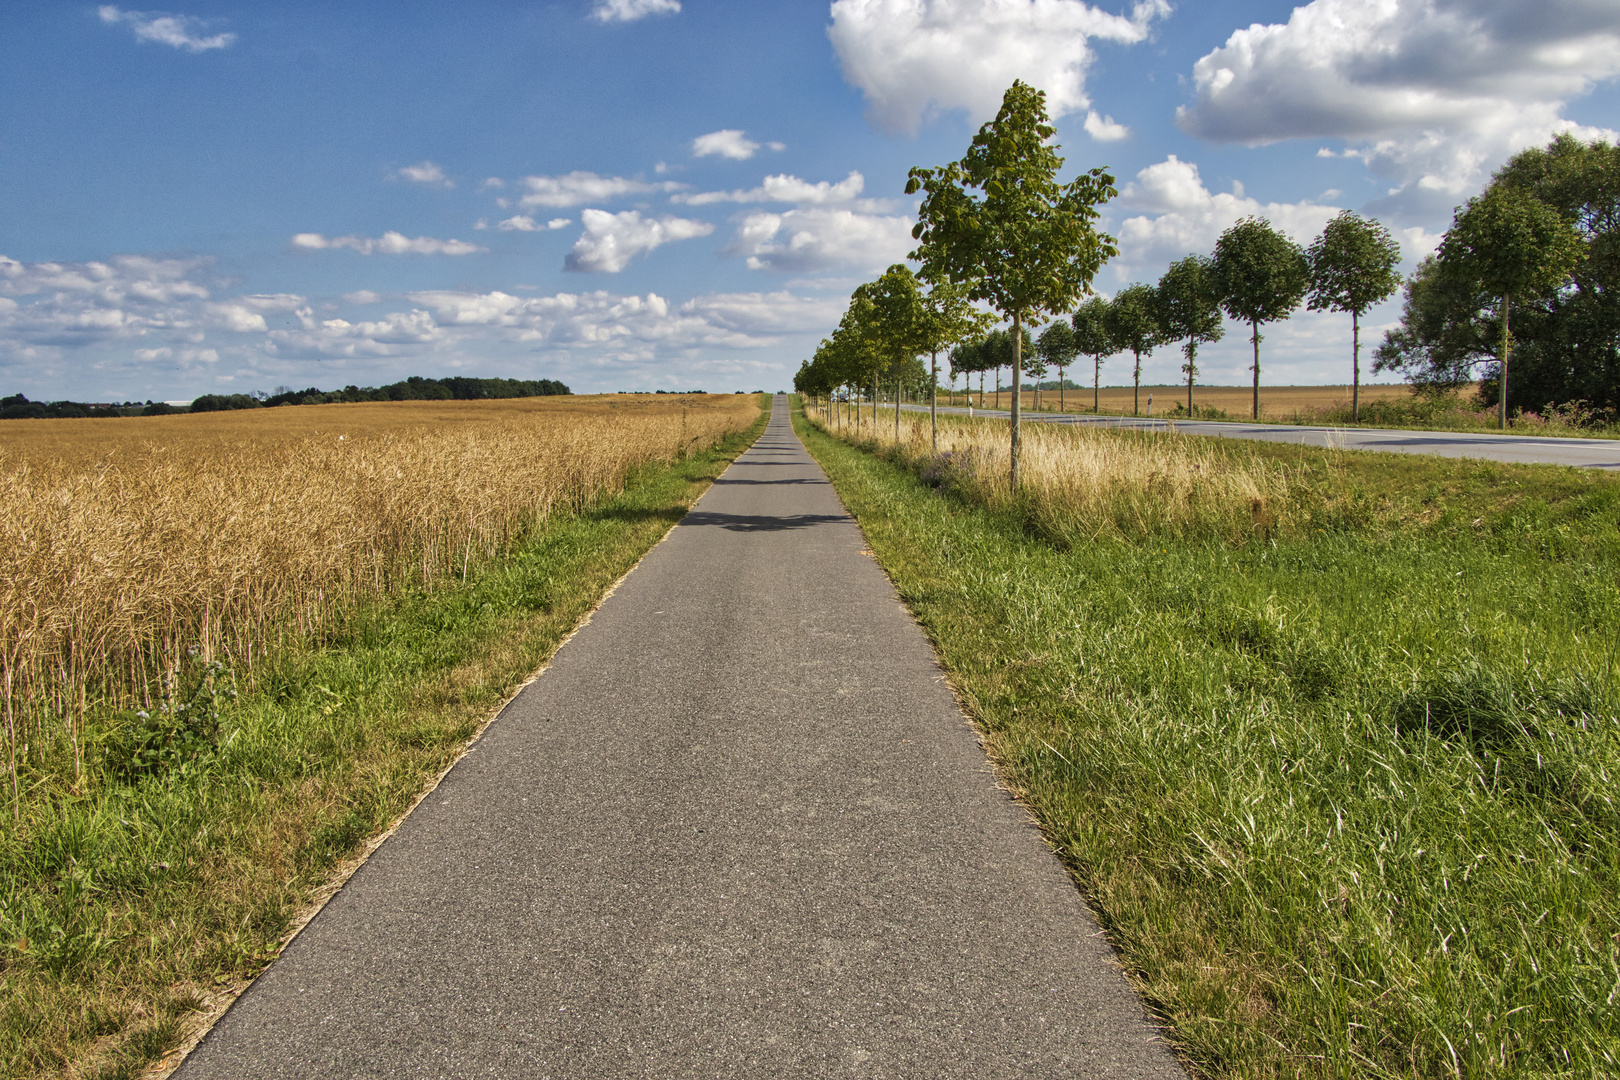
[795,81,1620,487]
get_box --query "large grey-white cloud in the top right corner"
[1176,0,1620,210]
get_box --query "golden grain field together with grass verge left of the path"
[0,395,765,1077]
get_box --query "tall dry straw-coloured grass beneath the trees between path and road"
[805,405,1291,542]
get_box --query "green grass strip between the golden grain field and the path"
[0,400,770,1077]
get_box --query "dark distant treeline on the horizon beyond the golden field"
[0,376,572,419]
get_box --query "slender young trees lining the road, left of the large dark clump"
[794,81,1400,487]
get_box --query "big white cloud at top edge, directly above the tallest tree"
[828,0,1170,134]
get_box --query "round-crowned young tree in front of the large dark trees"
[1440,185,1586,429]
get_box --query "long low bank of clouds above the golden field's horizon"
[0,247,846,398]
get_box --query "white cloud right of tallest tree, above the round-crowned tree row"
[1111,154,1340,283]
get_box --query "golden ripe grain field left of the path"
[0,395,758,777]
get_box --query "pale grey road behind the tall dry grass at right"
[907,395,1620,470]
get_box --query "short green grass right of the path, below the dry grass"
[795,401,1620,1077]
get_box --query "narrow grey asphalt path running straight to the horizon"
[177,398,1181,1080]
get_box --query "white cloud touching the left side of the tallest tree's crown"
[726,207,915,272]
